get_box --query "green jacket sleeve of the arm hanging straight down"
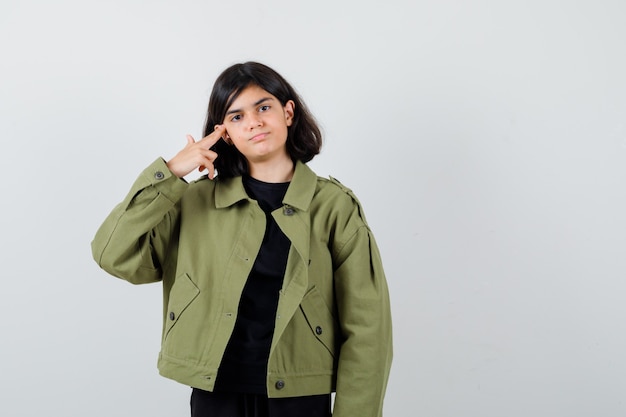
[333,192,392,417]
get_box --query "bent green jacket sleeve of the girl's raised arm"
[91,158,188,284]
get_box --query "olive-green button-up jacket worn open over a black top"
[92,159,392,417]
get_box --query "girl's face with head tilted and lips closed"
[224,85,295,164]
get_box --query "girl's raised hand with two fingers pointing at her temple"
[167,125,226,179]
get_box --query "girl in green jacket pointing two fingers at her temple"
[92,62,392,417]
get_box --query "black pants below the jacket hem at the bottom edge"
[191,388,331,417]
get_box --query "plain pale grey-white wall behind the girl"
[0,0,626,417]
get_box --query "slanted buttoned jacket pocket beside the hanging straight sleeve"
[300,287,338,357]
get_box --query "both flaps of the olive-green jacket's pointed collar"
[215,161,317,211]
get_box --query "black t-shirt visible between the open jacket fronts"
[215,176,291,394]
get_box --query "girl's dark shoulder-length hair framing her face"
[204,62,322,178]
